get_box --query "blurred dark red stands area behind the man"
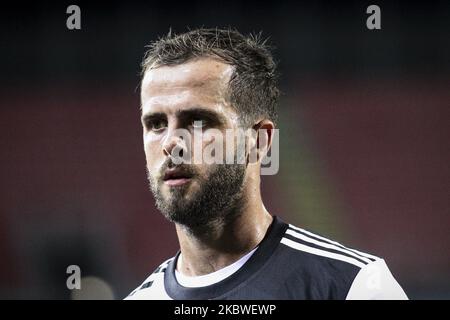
[0,79,450,298]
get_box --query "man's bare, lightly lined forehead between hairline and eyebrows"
[141,58,233,114]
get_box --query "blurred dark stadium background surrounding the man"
[0,1,450,299]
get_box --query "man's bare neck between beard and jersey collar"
[176,181,272,276]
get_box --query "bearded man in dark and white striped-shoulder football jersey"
[127,29,407,299]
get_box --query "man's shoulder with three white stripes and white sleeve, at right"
[280,224,406,299]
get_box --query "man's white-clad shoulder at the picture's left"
[125,257,174,300]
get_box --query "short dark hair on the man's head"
[141,28,280,126]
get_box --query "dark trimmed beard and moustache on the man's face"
[147,164,245,233]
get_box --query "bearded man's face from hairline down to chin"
[141,58,245,227]
